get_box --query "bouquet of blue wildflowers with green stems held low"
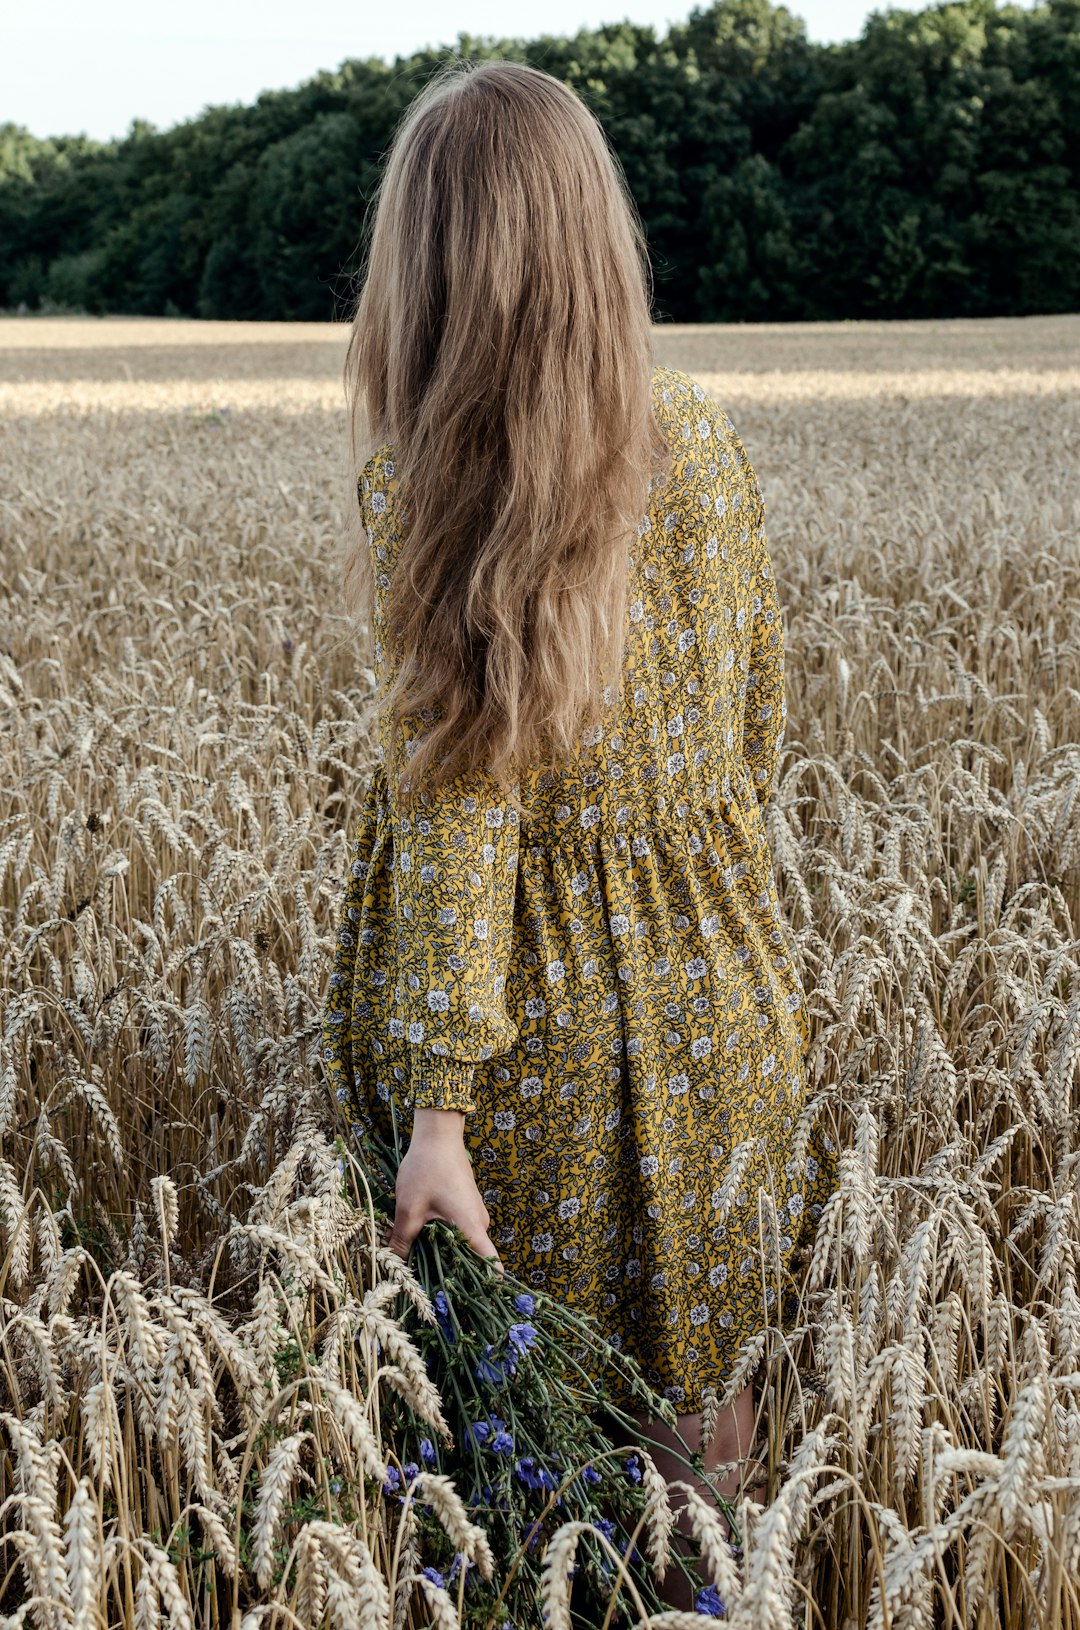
[350,1151,740,1630]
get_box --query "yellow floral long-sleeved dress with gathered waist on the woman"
[323,367,832,1413]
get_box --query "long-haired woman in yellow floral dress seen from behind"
[324,62,827,1606]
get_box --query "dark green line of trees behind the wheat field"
[0,0,1080,323]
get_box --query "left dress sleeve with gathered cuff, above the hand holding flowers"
[362,456,520,1113]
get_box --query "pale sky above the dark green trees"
[0,0,924,140]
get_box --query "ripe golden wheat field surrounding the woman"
[0,318,1080,1630]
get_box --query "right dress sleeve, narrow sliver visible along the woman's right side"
[735,437,787,807]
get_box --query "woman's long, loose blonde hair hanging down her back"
[344,60,668,813]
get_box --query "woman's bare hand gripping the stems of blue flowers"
[388,1108,502,1267]
